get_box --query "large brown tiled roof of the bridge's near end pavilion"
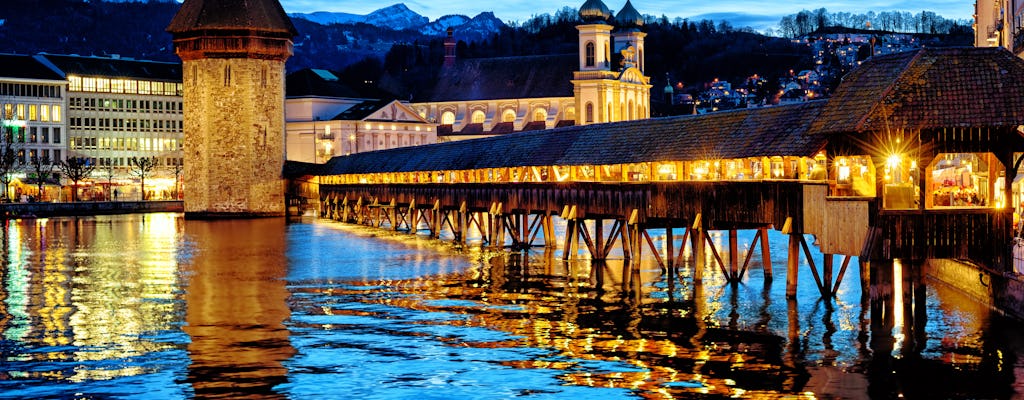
[811,47,1024,134]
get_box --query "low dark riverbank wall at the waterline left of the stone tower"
[0,201,184,219]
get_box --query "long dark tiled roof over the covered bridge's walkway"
[296,101,825,175]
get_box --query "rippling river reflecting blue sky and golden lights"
[0,213,1024,399]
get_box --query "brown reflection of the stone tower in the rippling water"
[183,219,295,398]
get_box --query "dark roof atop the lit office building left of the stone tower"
[41,54,181,82]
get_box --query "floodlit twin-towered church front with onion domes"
[572,0,650,125]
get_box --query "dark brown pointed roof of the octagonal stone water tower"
[167,0,298,38]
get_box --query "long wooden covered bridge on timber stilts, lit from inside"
[286,48,1024,297]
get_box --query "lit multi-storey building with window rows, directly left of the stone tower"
[39,54,183,199]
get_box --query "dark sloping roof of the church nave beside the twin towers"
[413,54,580,102]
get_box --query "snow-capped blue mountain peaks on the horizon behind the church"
[290,3,505,39]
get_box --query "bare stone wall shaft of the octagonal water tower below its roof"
[183,58,285,217]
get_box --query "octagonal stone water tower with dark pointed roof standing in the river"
[167,0,297,218]
